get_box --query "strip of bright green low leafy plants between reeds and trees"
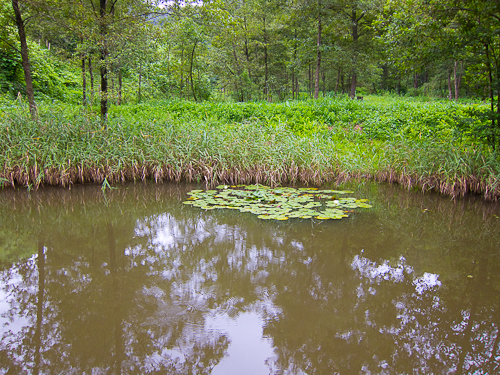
[111,96,489,144]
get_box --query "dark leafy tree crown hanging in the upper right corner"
[383,0,500,148]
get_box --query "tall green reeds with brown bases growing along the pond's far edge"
[0,98,500,200]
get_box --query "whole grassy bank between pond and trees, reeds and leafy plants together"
[0,98,500,200]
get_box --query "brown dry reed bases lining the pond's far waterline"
[0,162,500,202]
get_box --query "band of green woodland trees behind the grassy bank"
[0,0,500,137]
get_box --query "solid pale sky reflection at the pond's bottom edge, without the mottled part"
[205,312,277,375]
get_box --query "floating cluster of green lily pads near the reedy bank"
[183,184,372,220]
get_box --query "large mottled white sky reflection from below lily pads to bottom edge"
[134,214,286,375]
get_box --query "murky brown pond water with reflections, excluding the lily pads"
[0,183,500,375]
